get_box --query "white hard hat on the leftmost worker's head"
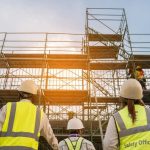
[18,80,38,94]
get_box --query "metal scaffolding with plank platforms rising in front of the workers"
[0,8,150,150]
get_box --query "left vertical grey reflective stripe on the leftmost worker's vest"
[7,103,16,134]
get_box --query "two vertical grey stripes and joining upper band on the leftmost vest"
[0,103,41,141]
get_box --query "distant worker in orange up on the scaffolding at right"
[134,66,146,90]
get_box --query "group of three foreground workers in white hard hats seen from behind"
[0,75,150,150]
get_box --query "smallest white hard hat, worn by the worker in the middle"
[67,117,84,130]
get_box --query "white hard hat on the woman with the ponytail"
[120,79,143,100]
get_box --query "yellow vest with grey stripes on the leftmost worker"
[0,102,42,150]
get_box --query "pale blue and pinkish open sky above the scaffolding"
[0,0,150,33]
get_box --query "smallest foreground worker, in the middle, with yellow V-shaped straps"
[59,117,95,150]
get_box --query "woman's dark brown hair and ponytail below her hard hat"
[121,97,144,123]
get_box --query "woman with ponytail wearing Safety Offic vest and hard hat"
[104,79,150,150]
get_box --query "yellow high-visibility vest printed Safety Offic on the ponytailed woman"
[114,105,150,150]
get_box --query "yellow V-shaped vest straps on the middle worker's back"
[65,137,83,150]
